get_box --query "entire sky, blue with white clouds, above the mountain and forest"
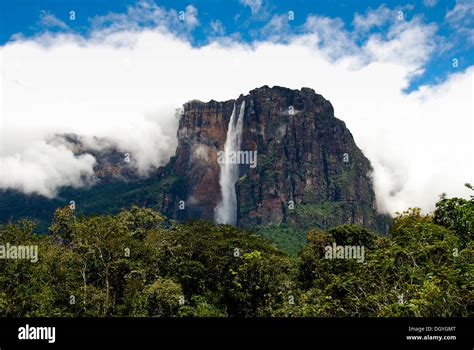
[0,0,474,213]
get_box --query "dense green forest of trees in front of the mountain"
[0,186,474,317]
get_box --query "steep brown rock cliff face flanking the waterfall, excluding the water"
[169,86,384,228]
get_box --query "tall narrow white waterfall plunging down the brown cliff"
[215,100,245,225]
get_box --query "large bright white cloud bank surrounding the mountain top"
[0,7,474,212]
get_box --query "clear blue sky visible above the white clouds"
[0,0,474,91]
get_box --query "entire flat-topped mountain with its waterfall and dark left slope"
[0,86,390,254]
